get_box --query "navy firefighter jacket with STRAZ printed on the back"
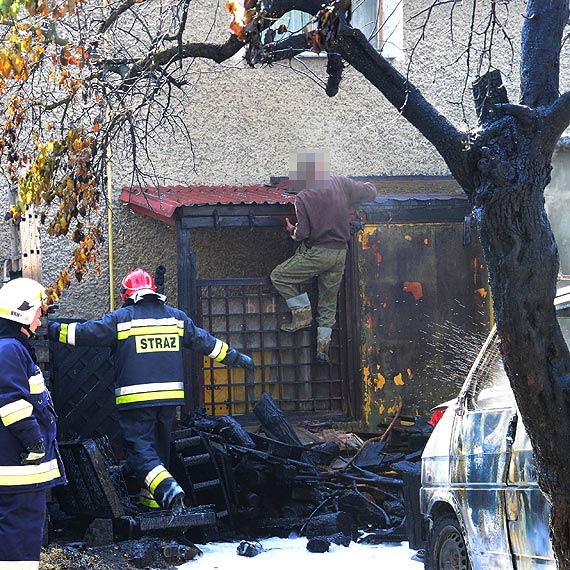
[49,295,228,408]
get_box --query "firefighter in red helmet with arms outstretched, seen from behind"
[49,268,253,509]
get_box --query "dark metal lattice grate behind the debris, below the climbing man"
[197,278,346,416]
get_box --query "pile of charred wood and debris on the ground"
[54,394,432,556]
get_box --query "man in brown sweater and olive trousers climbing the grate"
[271,151,376,363]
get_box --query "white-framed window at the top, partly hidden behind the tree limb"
[273,0,404,60]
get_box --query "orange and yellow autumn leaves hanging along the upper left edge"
[0,0,102,299]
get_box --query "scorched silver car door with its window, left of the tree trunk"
[450,335,517,570]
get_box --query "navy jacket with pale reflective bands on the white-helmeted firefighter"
[0,338,65,493]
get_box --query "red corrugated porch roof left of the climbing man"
[119,184,295,224]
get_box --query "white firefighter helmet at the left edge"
[0,277,46,325]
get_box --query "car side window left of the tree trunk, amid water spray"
[469,337,515,410]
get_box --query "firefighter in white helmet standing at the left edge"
[0,278,66,569]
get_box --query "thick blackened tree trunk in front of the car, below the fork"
[473,119,570,568]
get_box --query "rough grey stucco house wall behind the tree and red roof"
[0,0,570,317]
